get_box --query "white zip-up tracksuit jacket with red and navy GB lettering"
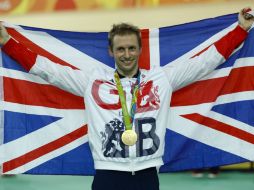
[3,26,247,171]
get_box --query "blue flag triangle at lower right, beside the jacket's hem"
[160,130,248,172]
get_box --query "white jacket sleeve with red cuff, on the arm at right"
[163,26,248,91]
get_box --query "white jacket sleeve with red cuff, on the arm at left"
[2,39,89,96]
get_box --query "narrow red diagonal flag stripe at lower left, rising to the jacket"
[3,125,87,173]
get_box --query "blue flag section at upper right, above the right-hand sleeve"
[160,14,237,66]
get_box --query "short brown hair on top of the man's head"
[108,23,142,50]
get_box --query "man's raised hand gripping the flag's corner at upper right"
[238,7,254,31]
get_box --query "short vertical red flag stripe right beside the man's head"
[138,29,150,70]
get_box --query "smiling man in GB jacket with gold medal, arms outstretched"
[0,9,254,190]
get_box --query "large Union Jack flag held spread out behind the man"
[0,14,254,175]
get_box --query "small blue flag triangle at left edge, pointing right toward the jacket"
[4,111,60,143]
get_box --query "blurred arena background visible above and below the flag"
[0,0,254,190]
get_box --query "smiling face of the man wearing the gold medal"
[110,34,141,77]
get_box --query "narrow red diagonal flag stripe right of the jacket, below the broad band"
[181,113,254,144]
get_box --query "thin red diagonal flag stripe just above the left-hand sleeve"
[7,28,77,69]
